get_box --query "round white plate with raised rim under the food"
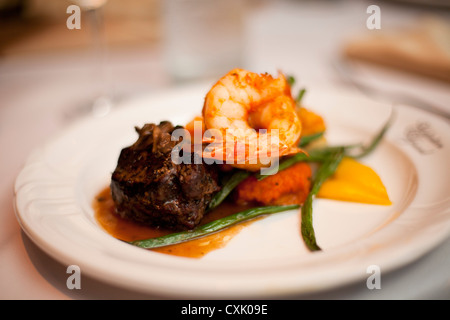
[15,85,450,298]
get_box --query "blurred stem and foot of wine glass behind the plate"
[67,0,113,120]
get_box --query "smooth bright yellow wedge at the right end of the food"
[317,158,392,205]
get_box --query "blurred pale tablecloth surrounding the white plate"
[0,1,450,299]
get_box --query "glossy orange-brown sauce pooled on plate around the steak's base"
[93,187,255,258]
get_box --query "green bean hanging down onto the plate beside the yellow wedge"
[301,148,345,251]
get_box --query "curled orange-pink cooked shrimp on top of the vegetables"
[202,69,302,171]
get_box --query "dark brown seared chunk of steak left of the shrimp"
[111,121,219,230]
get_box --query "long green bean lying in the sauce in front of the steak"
[129,205,300,249]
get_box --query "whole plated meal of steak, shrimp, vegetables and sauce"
[93,69,391,257]
